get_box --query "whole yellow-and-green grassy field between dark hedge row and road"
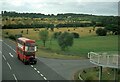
[3,27,118,59]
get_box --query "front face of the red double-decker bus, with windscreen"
[24,40,37,64]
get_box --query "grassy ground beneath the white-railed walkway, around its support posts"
[74,67,120,80]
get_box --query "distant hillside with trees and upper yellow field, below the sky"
[2,11,118,29]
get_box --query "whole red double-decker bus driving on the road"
[16,37,37,65]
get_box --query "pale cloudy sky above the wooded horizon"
[0,0,119,16]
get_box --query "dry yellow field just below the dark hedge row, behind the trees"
[3,27,100,40]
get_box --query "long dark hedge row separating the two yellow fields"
[2,23,101,29]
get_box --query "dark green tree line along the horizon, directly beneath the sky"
[2,11,118,26]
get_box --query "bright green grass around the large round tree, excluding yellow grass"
[37,36,118,56]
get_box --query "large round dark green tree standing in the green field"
[58,32,74,51]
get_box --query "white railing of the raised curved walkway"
[88,52,120,68]
